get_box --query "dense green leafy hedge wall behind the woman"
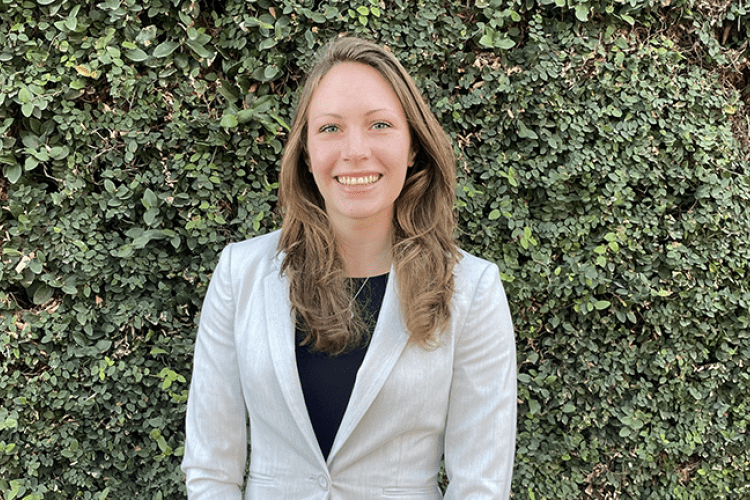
[0,0,750,500]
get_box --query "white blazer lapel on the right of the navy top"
[328,268,409,464]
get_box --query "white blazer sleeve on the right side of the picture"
[445,264,517,500]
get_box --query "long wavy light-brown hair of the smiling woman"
[278,37,460,355]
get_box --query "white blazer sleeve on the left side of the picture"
[182,245,247,500]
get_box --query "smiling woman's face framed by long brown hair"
[307,62,414,231]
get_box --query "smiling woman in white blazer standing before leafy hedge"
[182,38,516,500]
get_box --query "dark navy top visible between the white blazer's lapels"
[296,273,388,459]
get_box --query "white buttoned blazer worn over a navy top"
[182,231,516,500]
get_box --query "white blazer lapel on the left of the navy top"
[263,269,325,464]
